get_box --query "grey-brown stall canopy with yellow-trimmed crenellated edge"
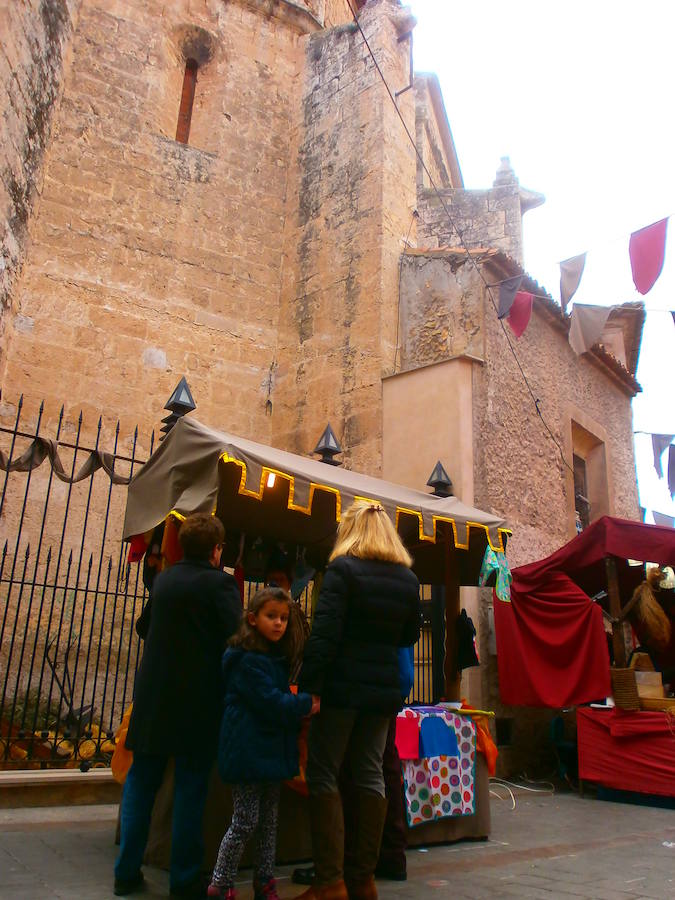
[124,417,510,585]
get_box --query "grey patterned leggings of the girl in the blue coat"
[212,784,281,887]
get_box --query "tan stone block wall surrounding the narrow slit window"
[3,0,308,450]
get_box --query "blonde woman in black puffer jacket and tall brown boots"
[300,500,421,900]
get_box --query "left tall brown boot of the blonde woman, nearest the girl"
[296,793,349,900]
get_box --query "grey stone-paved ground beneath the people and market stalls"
[0,793,675,900]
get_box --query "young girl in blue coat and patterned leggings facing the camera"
[208,587,319,900]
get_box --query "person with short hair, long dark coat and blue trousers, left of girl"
[114,513,241,897]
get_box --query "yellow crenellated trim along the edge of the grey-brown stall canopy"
[161,452,512,553]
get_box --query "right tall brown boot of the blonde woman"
[345,789,387,900]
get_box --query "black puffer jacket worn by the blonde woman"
[300,556,421,714]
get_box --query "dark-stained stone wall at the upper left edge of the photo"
[0,0,79,380]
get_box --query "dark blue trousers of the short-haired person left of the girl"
[115,753,212,890]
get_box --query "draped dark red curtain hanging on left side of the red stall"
[494,569,611,709]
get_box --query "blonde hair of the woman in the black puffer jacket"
[329,500,412,568]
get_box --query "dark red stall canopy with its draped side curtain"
[494,516,675,708]
